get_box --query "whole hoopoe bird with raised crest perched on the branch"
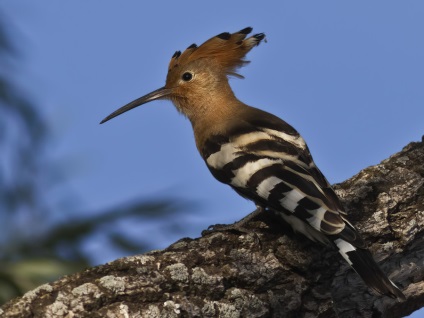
[101,27,405,300]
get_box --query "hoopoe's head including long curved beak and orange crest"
[100,27,265,124]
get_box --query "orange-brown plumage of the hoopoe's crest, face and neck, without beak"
[161,27,265,150]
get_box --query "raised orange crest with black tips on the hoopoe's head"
[169,27,265,75]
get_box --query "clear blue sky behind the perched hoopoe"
[0,0,424,314]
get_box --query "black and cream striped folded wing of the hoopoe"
[204,119,345,235]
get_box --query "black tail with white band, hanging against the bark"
[334,238,406,300]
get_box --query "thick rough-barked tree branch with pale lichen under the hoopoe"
[0,142,424,317]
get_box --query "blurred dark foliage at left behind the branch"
[0,12,187,303]
